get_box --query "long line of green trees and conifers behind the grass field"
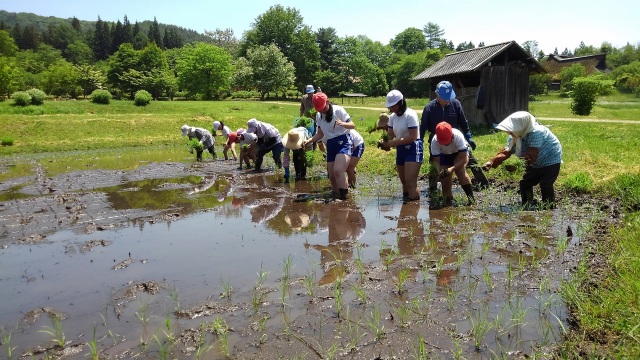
[0,5,640,99]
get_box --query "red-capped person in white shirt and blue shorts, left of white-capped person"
[304,93,356,200]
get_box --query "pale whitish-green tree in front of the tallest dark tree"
[247,44,295,100]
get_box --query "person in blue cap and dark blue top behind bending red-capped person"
[420,81,489,193]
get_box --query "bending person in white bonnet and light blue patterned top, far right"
[483,111,562,207]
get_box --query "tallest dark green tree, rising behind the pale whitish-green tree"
[241,5,320,88]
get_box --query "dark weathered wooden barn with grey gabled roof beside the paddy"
[413,41,547,124]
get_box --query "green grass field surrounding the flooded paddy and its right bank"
[0,94,640,358]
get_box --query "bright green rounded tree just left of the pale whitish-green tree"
[176,42,233,99]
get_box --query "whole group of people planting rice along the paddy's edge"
[182,81,562,206]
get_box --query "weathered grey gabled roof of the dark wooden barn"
[413,41,546,80]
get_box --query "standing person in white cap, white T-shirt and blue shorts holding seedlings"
[381,90,424,202]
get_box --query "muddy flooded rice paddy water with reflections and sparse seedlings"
[0,161,593,359]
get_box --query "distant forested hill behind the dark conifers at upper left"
[0,10,206,44]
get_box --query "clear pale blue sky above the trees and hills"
[0,0,640,53]
